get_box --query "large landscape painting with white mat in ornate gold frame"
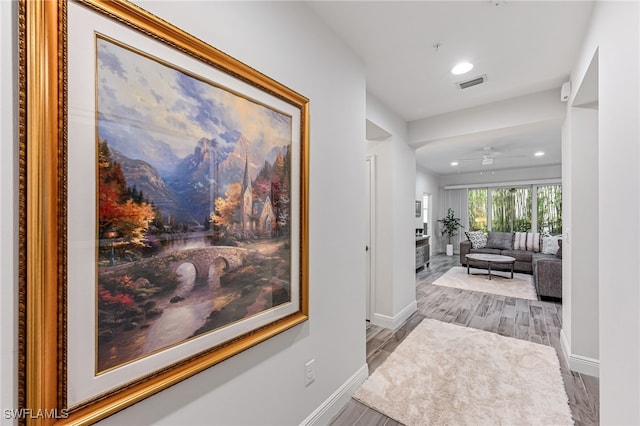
[18,0,309,424]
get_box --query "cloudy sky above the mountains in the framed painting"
[97,38,291,160]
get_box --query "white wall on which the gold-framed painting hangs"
[0,1,368,425]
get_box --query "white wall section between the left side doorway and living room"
[366,93,416,327]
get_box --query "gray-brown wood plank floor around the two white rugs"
[331,255,599,426]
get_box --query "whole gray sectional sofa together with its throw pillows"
[460,231,562,298]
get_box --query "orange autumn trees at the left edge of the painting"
[98,140,155,246]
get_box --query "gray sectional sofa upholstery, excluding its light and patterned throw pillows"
[460,232,562,298]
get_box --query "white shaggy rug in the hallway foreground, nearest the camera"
[354,319,573,426]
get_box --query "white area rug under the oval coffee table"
[433,266,538,300]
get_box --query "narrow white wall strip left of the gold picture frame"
[0,1,18,424]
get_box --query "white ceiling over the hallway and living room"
[308,0,593,175]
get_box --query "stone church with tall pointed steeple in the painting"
[238,154,275,240]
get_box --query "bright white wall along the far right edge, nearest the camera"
[565,2,640,425]
